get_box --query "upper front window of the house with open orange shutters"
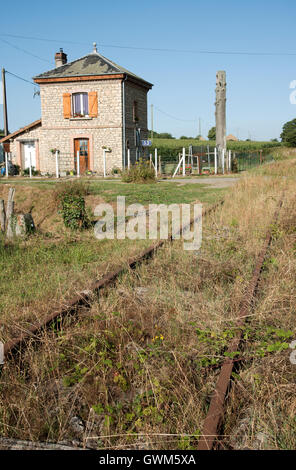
[63,91,98,119]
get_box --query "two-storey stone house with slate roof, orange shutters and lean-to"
[0,43,152,175]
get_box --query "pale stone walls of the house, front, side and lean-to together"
[10,79,148,174]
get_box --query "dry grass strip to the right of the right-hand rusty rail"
[224,182,296,450]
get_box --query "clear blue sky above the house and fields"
[0,0,296,140]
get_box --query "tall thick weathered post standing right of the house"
[215,70,226,168]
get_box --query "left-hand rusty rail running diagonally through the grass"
[3,200,224,360]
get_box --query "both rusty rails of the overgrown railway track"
[4,195,284,450]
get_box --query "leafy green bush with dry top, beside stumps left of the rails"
[55,181,90,230]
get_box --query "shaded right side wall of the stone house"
[124,80,148,163]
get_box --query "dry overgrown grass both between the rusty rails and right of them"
[0,153,296,449]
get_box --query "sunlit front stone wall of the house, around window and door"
[39,79,122,174]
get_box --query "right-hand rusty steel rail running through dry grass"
[197,196,283,450]
